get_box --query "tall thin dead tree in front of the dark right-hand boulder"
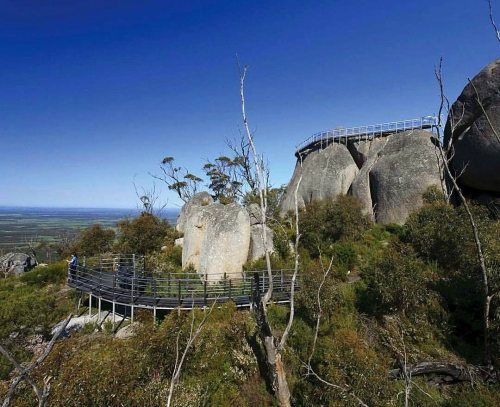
[435,58,498,365]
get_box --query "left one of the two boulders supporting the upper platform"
[281,143,359,215]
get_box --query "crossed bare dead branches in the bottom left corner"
[0,314,73,407]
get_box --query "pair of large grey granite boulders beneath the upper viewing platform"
[281,130,442,224]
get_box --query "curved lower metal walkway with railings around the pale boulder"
[68,256,293,318]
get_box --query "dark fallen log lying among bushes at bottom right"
[389,362,498,384]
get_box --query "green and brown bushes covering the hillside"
[0,191,500,407]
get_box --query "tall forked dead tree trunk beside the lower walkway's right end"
[240,61,300,407]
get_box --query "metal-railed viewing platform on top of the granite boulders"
[295,116,438,157]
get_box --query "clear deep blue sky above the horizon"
[0,0,500,207]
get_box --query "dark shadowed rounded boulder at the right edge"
[444,59,500,192]
